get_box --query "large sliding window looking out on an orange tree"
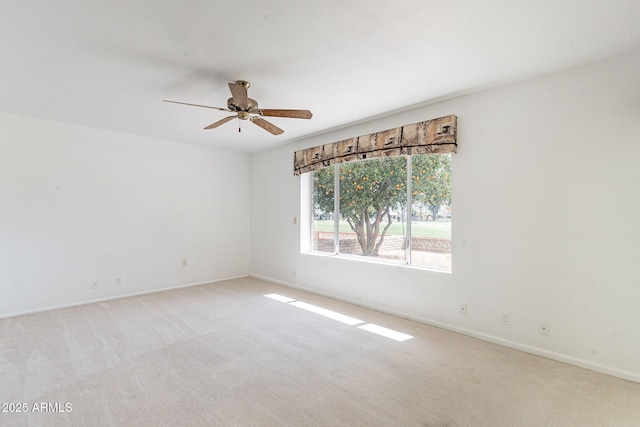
[311,154,451,271]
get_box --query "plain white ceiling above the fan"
[0,0,640,152]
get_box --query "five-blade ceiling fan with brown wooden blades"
[163,80,312,135]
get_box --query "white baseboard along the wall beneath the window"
[250,274,640,383]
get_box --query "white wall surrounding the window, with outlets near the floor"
[251,52,640,381]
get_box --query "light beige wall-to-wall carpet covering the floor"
[0,278,640,427]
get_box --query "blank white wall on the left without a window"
[0,114,250,317]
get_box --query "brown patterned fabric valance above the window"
[293,115,458,175]
